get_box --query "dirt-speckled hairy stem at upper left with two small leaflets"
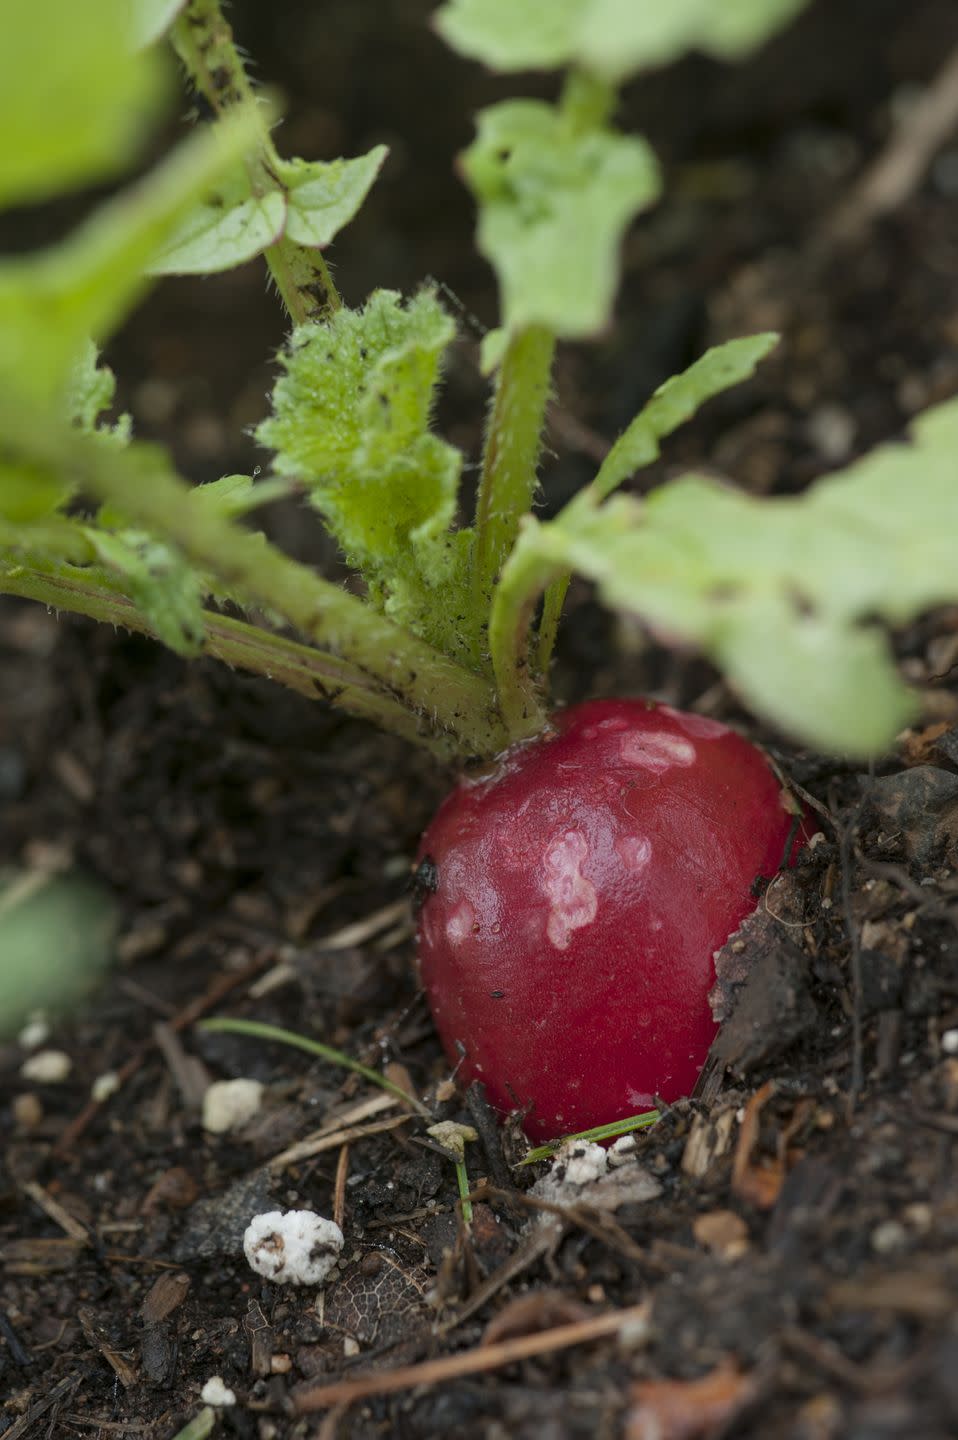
[170,0,341,325]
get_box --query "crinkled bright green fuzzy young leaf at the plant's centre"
[256,291,468,649]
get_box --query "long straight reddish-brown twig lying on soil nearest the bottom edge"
[292,1303,650,1416]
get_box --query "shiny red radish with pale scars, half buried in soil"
[419,700,792,1139]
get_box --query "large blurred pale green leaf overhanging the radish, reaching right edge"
[515,400,958,756]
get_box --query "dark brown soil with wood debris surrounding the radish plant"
[0,0,958,1440]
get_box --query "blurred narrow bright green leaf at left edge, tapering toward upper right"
[0,105,259,408]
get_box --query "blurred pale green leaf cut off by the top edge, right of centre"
[435,0,808,84]
